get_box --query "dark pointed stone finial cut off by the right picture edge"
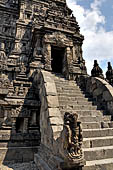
[106,62,113,85]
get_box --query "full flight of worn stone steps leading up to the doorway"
[54,75,113,170]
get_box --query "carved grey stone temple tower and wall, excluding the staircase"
[0,0,86,167]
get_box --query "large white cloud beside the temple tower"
[67,0,113,74]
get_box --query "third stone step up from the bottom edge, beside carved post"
[83,136,113,148]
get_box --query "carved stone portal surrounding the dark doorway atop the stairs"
[34,26,86,78]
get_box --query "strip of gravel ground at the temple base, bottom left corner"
[0,162,38,170]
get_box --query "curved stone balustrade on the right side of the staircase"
[77,76,113,115]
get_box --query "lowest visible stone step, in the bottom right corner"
[82,158,113,170]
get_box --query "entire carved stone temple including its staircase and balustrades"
[0,0,113,170]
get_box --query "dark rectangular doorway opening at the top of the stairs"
[51,46,65,73]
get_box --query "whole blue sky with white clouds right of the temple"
[67,0,113,74]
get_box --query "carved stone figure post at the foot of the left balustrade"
[61,112,83,161]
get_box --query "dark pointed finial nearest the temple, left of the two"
[91,60,104,78]
